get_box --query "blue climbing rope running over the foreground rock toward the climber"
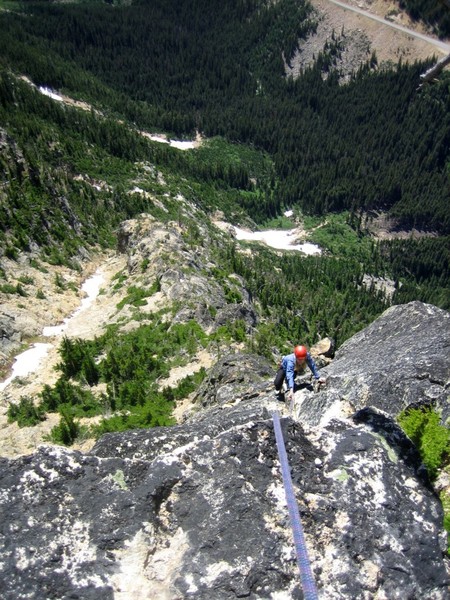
[272,411,318,600]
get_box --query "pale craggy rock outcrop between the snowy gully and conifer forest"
[118,215,257,333]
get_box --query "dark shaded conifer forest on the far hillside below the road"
[0,0,450,234]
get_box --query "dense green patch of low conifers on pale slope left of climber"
[41,315,208,435]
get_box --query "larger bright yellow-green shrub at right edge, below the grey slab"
[398,407,450,479]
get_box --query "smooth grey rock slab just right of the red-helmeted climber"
[299,302,450,425]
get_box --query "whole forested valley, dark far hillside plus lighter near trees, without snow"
[0,0,450,350]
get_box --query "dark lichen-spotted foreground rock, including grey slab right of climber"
[0,303,450,600]
